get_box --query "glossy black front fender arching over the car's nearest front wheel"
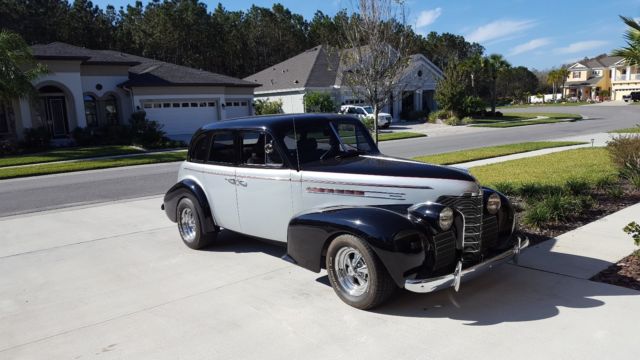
[287,207,428,286]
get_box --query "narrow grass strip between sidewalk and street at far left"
[0,150,187,179]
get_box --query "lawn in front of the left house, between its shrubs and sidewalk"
[0,145,144,167]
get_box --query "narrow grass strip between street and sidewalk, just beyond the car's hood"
[414,141,585,165]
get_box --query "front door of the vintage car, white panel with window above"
[236,130,292,242]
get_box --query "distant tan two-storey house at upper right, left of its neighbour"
[563,55,622,101]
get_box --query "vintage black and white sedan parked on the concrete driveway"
[162,114,528,309]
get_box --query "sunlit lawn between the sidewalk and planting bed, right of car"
[470,148,617,186]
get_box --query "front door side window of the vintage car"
[241,131,283,167]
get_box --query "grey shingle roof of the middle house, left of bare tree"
[244,46,338,91]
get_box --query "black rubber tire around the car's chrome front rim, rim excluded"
[326,234,397,310]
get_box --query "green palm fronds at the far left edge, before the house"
[0,30,47,101]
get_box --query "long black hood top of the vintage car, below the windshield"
[301,156,476,182]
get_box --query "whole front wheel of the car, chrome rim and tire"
[326,235,396,310]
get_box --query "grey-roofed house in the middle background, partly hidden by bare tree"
[244,46,443,119]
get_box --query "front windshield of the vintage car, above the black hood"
[284,120,379,164]
